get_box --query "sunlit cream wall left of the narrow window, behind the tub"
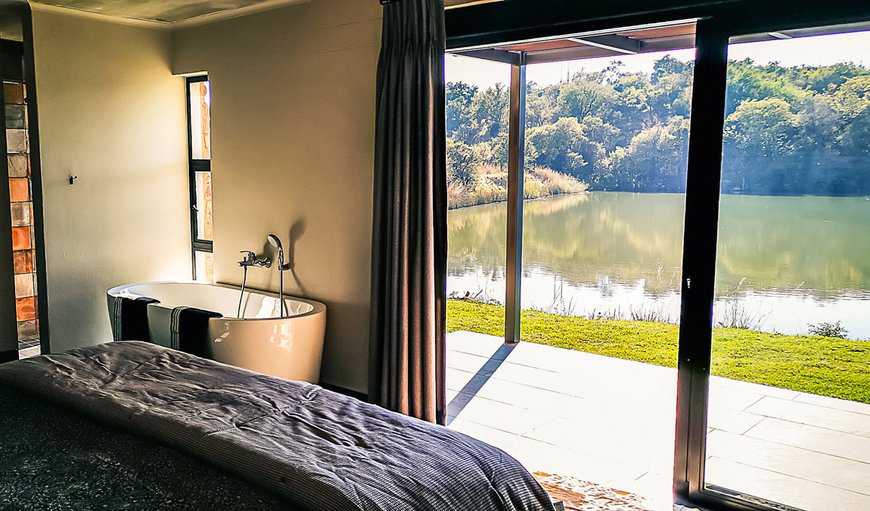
[33,6,190,351]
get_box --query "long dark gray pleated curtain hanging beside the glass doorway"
[369,0,447,424]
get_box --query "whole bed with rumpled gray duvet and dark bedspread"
[0,341,553,511]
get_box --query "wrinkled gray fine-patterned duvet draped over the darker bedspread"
[0,342,553,511]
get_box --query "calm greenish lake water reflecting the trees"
[447,192,870,339]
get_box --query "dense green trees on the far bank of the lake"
[447,56,870,196]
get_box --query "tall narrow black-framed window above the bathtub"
[187,76,214,282]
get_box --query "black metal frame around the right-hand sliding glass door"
[674,14,870,511]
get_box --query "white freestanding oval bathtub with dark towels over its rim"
[107,282,326,383]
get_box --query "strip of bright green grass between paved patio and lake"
[447,300,870,403]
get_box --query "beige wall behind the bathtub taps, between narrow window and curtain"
[172,0,381,391]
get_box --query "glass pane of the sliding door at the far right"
[704,26,870,510]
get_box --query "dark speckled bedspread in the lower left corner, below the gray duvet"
[0,384,300,511]
